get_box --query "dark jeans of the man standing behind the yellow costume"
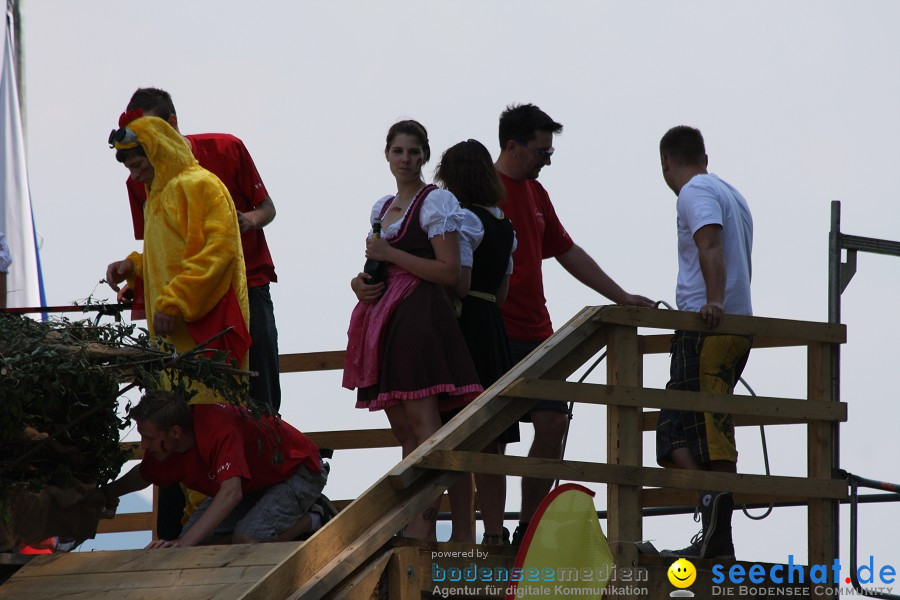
[247,283,281,413]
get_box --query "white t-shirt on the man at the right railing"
[675,174,753,315]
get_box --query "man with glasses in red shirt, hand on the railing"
[494,104,654,543]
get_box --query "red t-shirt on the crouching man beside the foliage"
[141,404,322,496]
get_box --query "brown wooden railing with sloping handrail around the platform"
[95,306,848,600]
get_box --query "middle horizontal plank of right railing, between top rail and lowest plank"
[504,379,847,421]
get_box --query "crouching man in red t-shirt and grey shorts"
[102,391,327,548]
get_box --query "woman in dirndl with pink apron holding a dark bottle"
[343,120,482,543]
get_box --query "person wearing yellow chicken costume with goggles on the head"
[106,110,250,539]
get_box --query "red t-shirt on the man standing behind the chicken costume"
[125,133,278,287]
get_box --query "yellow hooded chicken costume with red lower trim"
[126,117,250,402]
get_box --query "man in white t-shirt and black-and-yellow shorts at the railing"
[656,125,753,559]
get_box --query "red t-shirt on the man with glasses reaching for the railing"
[500,173,575,342]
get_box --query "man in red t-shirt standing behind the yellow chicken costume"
[126,88,281,413]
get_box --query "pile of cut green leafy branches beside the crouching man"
[0,313,259,514]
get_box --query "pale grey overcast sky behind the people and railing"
[14,0,900,566]
